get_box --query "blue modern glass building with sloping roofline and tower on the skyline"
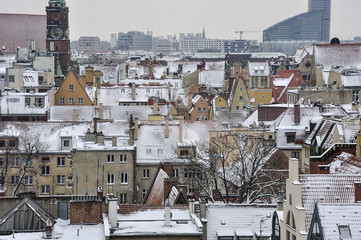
[263,0,331,42]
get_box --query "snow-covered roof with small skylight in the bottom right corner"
[317,203,361,240]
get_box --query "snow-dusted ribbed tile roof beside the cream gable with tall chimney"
[299,174,361,231]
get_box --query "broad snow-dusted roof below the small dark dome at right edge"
[315,44,361,71]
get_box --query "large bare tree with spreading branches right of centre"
[172,132,287,203]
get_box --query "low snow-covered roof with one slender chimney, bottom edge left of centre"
[111,209,202,235]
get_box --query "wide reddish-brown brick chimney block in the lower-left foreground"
[70,201,102,224]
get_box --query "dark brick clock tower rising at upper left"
[46,0,70,85]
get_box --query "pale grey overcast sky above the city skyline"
[0,0,361,41]
